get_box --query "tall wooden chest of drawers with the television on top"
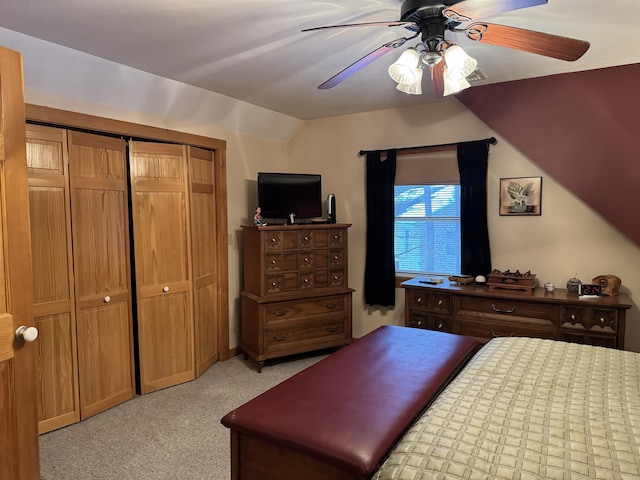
[240,224,353,371]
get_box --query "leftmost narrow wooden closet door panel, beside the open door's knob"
[27,125,80,433]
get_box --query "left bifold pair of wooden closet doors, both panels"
[27,125,135,433]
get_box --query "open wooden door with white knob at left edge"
[0,43,40,480]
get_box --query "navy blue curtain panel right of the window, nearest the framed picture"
[458,140,491,276]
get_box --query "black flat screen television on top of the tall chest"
[258,172,322,219]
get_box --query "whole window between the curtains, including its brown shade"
[394,148,461,275]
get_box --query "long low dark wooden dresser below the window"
[402,277,631,349]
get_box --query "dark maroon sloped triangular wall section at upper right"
[457,63,640,244]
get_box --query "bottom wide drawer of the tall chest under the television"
[264,317,348,354]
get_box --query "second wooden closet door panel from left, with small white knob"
[68,131,135,420]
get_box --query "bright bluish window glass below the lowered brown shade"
[394,185,460,274]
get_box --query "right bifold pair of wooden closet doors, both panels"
[129,141,219,393]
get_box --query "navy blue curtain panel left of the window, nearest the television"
[364,150,396,307]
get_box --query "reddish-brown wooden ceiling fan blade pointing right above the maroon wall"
[458,23,590,62]
